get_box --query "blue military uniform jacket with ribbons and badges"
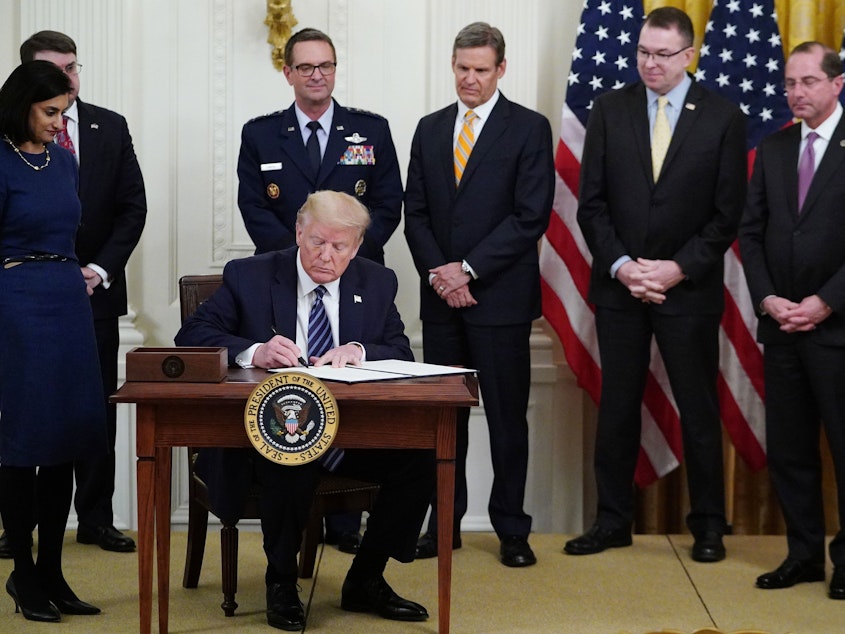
[232,102,402,263]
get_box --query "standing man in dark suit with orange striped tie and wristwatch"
[405,22,554,566]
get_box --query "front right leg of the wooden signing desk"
[437,409,456,634]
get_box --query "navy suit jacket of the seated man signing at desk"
[176,247,413,365]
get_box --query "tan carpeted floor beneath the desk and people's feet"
[0,529,845,634]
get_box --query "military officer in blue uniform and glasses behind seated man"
[238,29,403,264]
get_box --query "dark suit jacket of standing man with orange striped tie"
[405,95,554,326]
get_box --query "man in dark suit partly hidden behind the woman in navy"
[7,31,147,552]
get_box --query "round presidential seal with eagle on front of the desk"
[244,372,338,465]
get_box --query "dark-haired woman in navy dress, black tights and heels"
[0,61,108,621]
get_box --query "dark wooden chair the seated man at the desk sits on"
[179,275,378,616]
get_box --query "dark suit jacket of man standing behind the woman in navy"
[76,99,147,319]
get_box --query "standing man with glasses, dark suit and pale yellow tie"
[564,7,746,562]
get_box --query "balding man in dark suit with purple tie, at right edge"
[739,42,845,599]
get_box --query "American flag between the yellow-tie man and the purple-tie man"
[695,0,792,469]
